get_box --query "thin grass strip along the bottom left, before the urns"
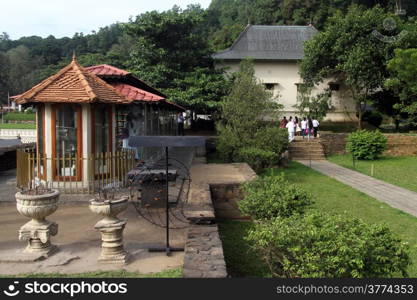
[0,268,182,278]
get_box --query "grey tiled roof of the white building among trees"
[213,25,318,60]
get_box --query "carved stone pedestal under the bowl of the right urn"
[94,220,129,264]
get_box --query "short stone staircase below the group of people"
[288,139,326,160]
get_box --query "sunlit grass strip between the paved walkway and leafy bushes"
[274,162,417,277]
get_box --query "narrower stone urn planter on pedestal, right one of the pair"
[90,196,129,264]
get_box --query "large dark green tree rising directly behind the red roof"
[126,6,210,89]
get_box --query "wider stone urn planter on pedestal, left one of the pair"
[15,189,59,256]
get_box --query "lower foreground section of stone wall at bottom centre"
[183,225,227,278]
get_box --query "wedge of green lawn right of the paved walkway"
[328,154,417,192]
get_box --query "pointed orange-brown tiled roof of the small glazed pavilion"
[15,57,129,104]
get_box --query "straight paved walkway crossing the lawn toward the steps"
[299,161,417,217]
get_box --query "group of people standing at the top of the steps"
[279,117,320,142]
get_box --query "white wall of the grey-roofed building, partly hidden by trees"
[217,61,356,121]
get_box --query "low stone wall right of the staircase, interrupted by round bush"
[320,132,417,156]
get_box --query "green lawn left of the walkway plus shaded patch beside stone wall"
[219,162,417,277]
